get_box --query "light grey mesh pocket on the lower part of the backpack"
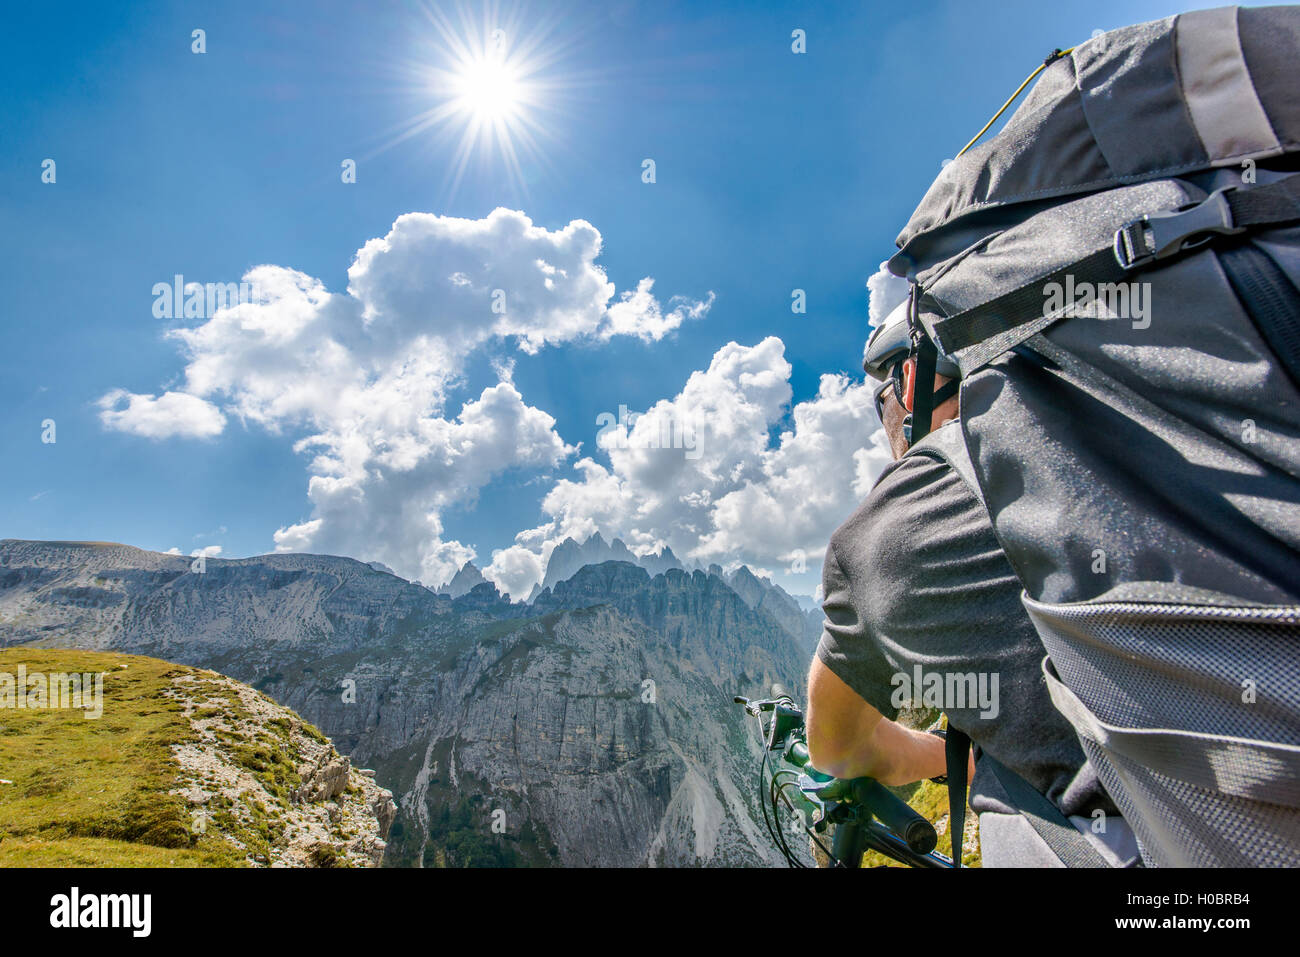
[1023,596,1300,866]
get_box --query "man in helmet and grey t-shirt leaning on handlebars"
[807,304,1138,867]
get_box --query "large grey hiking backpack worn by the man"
[889,7,1300,866]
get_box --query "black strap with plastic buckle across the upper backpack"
[933,174,1300,374]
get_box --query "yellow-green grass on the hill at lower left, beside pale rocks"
[0,649,243,867]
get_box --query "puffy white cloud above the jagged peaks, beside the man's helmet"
[488,337,891,594]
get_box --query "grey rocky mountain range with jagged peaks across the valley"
[0,541,807,866]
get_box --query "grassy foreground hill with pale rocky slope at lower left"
[0,648,397,867]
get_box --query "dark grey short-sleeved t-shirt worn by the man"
[816,444,1115,815]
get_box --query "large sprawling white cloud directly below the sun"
[100,209,712,583]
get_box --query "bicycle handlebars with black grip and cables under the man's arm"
[735,694,953,867]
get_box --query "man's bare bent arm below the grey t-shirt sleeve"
[805,657,974,787]
